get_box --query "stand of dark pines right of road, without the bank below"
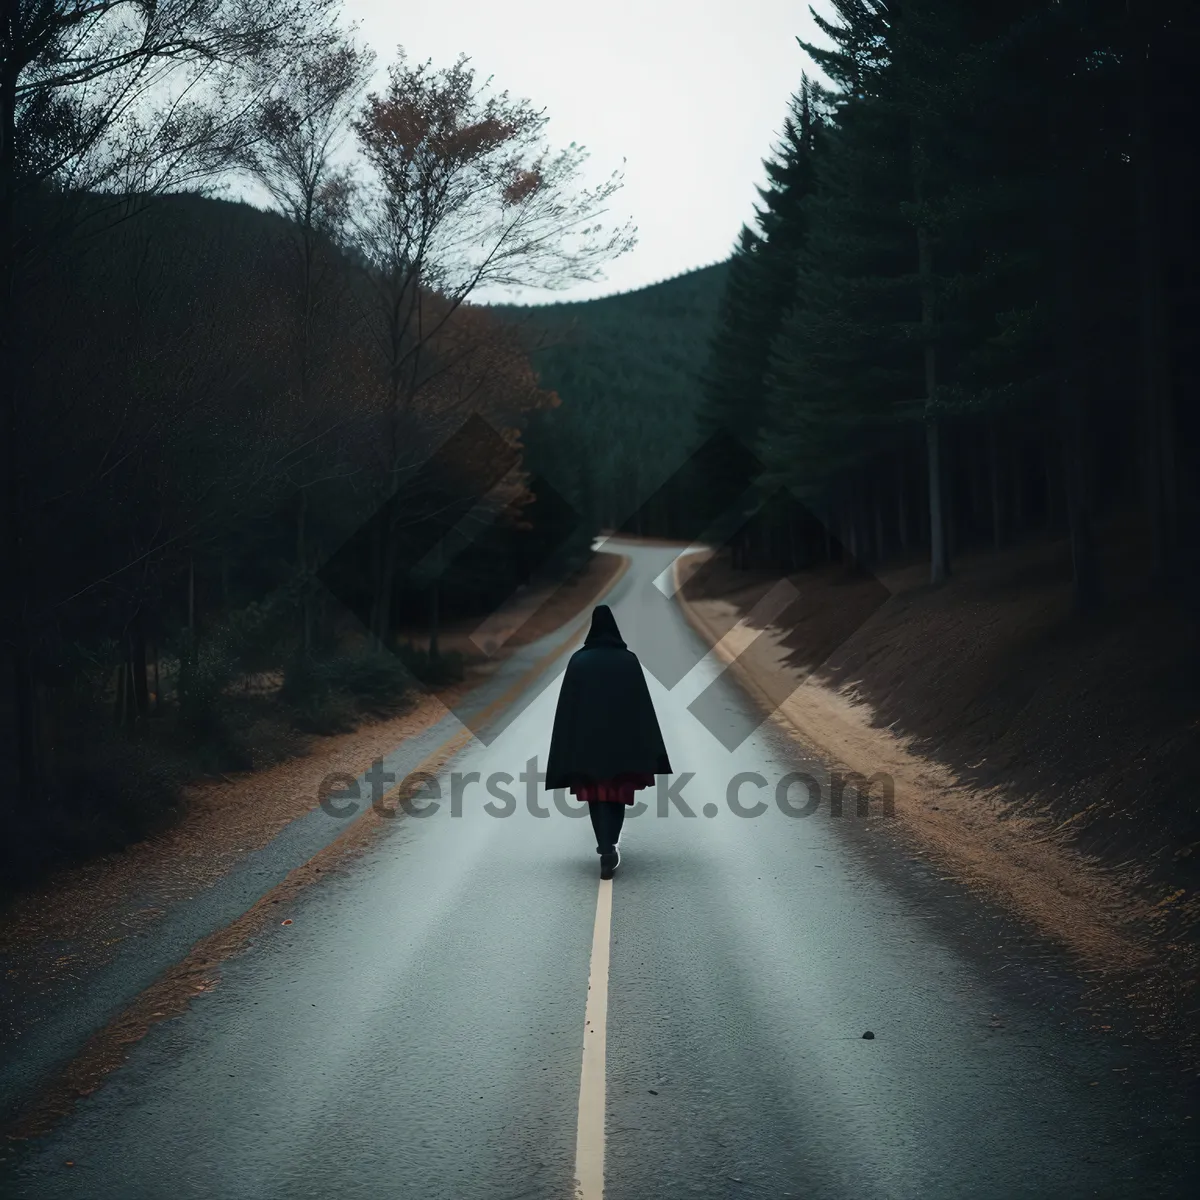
[702,0,1200,600]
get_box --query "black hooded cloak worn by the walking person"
[546,604,671,791]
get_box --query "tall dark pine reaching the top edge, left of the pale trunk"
[760,0,919,516]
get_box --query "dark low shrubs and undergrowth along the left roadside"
[0,635,466,895]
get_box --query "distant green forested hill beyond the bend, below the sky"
[491,263,728,532]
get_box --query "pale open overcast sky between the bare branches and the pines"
[344,0,823,302]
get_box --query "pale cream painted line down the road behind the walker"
[575,880,612,1200]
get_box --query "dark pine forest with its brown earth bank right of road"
[662,0,1200,916]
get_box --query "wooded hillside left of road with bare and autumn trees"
[0,23,631,884]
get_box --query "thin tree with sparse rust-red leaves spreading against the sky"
[355,49,636,640]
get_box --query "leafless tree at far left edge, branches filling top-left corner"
[0,0,336,802]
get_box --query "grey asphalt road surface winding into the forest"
[0,547,1190,1200]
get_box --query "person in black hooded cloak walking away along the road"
[546,604,671,880]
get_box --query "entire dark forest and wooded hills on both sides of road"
[0,0,1200,874]
